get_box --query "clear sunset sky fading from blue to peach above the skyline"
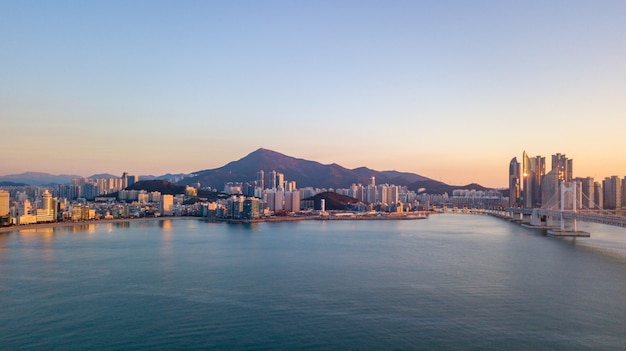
[0,0,626,187]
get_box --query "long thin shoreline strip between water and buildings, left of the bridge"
[0,215,428,234]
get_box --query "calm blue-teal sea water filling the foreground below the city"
[0,215,626,350]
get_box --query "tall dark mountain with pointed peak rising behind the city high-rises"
[179,148,429,189]
